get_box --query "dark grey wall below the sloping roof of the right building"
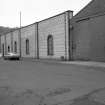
[73,15,105,61]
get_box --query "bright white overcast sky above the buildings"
[0,0,91,27]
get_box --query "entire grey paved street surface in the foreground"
[0,60,105,105]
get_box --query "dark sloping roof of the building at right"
[74,0,105,19]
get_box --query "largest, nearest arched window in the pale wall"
[47,35,54,55]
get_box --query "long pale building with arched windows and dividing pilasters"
[0,11,73,60]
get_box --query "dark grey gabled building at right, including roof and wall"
[71,0,105,61]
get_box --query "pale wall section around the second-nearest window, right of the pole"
[21,24,37,58]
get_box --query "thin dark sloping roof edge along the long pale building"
[1,10,73,36]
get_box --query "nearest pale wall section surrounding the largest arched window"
[38,14,65,59]
